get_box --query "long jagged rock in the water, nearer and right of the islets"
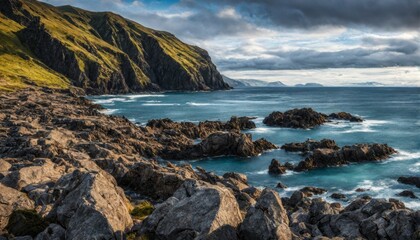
[295,143,396,171]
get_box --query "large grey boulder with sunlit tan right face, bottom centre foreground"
[139,180,242,239]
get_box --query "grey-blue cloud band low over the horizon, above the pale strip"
[217,39,420,70]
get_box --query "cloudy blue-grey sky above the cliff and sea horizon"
[43,0,420,86]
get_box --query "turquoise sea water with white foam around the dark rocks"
[92,88,420,209]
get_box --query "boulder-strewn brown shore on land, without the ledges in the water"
[0,89,420,239]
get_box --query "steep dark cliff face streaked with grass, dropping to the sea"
[0,0,229,94]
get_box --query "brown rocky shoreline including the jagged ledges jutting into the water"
[0,88,420,239]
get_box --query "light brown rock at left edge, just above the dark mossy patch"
[0,183,35,234]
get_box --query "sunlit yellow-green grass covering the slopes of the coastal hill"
[0,0,213,90]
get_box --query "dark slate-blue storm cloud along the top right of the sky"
[206,0,420,29]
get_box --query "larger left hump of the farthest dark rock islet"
[263,108,327,128]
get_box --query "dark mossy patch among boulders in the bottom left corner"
[6,210,49,237]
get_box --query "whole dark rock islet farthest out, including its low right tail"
[263,108,363,129]
